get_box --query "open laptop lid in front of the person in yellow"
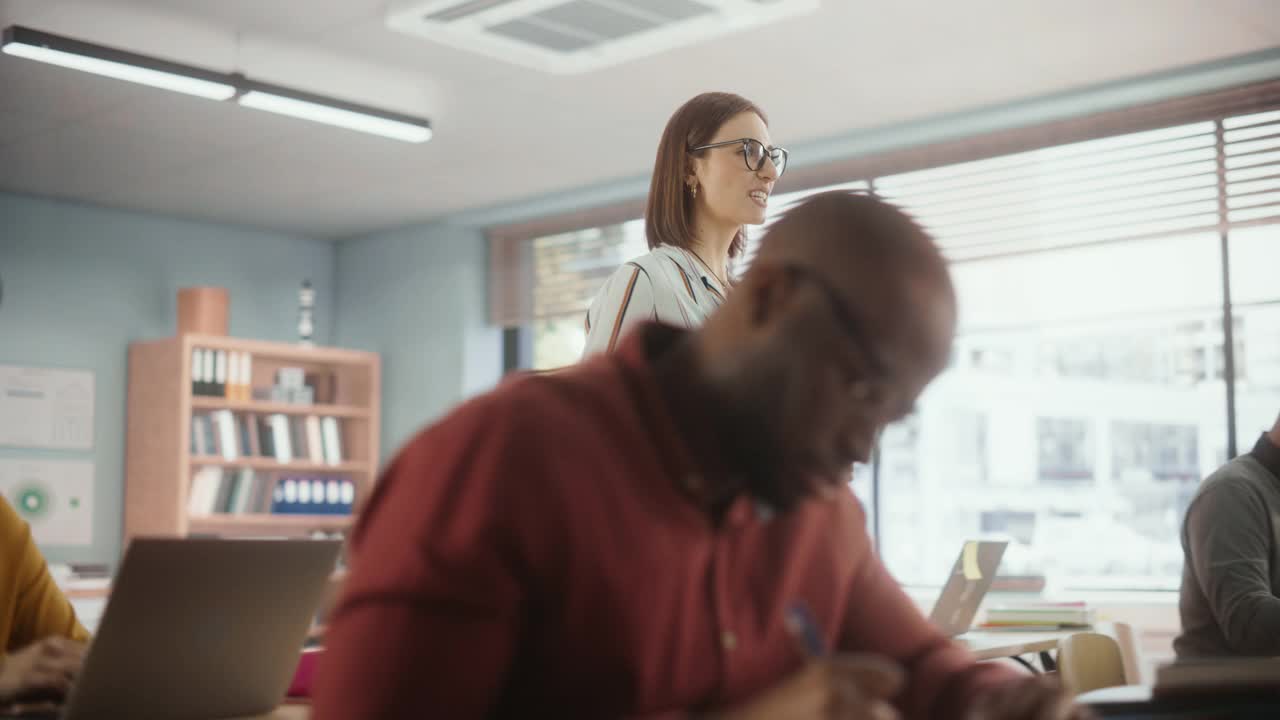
[12,538,342,720]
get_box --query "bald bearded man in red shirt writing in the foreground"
[314,192,1084,720]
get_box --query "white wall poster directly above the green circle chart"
[0,365,93,450]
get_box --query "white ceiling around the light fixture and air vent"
[0,0,1280,238]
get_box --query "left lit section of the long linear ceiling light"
[3,28,236,100]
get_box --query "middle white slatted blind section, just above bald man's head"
[876,123,1219,259]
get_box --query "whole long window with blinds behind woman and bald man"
[494,92,1280,591]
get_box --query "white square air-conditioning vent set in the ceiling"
[387,0,819,74]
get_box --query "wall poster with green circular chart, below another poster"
[0,459,93,547]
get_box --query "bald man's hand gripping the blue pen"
[716,655,904,720]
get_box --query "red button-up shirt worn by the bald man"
[312,325,1016,720]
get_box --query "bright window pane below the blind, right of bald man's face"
[878,233,1226,588]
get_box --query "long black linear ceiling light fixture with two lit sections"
[0,26,431,142]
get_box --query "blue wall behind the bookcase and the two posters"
[0,193,335,564]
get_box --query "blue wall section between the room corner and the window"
[335,223,502,460]
